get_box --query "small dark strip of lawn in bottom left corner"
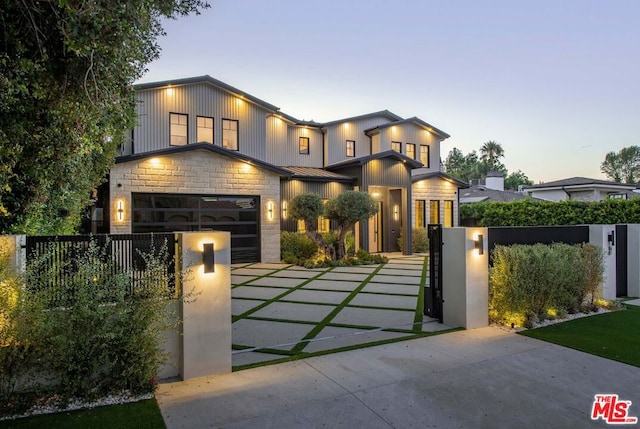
[0,398,166,429]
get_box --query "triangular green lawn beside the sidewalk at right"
[520,305,640,367]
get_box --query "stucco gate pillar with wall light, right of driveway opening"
[442,227,489,329]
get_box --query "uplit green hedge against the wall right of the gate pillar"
[489,243,604,327]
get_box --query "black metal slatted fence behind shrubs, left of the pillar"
[25,233,177,305]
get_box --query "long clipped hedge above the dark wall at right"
[460,198,640,226]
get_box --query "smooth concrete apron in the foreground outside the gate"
[156,327,640,429]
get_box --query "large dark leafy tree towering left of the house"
[0,0,208,234]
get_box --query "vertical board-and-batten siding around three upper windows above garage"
[132,83,271,159]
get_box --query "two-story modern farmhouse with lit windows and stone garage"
[102,76,466,262]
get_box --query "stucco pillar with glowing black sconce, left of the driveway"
[181,232,231,380]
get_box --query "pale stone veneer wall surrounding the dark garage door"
[109,150,280,262]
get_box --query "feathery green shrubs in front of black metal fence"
[3,236,185,412]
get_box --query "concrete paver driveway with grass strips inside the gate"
[231,254,451,369]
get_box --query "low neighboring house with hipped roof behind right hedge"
[522,177,637,201]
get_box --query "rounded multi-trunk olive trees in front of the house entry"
[289,191,378,259]
